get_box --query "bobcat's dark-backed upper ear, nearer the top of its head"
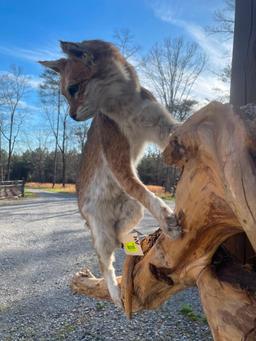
[60,41,94,66]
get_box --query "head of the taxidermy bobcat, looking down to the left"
[39,40,139,121]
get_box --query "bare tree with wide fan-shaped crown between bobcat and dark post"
[141,38,206,120]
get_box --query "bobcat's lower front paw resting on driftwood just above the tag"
[160,207,182,240]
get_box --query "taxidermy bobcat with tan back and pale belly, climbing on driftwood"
[40,40,181,305]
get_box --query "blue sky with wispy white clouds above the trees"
[0,0,232,149]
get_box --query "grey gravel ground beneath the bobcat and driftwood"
[0,191,212,341]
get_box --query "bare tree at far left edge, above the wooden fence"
[0,65,29,180]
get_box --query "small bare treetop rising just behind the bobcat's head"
[113,29,140,60]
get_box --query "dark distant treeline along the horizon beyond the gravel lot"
[0,148,178,190]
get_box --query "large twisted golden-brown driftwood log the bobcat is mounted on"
[72,102,256,341]
